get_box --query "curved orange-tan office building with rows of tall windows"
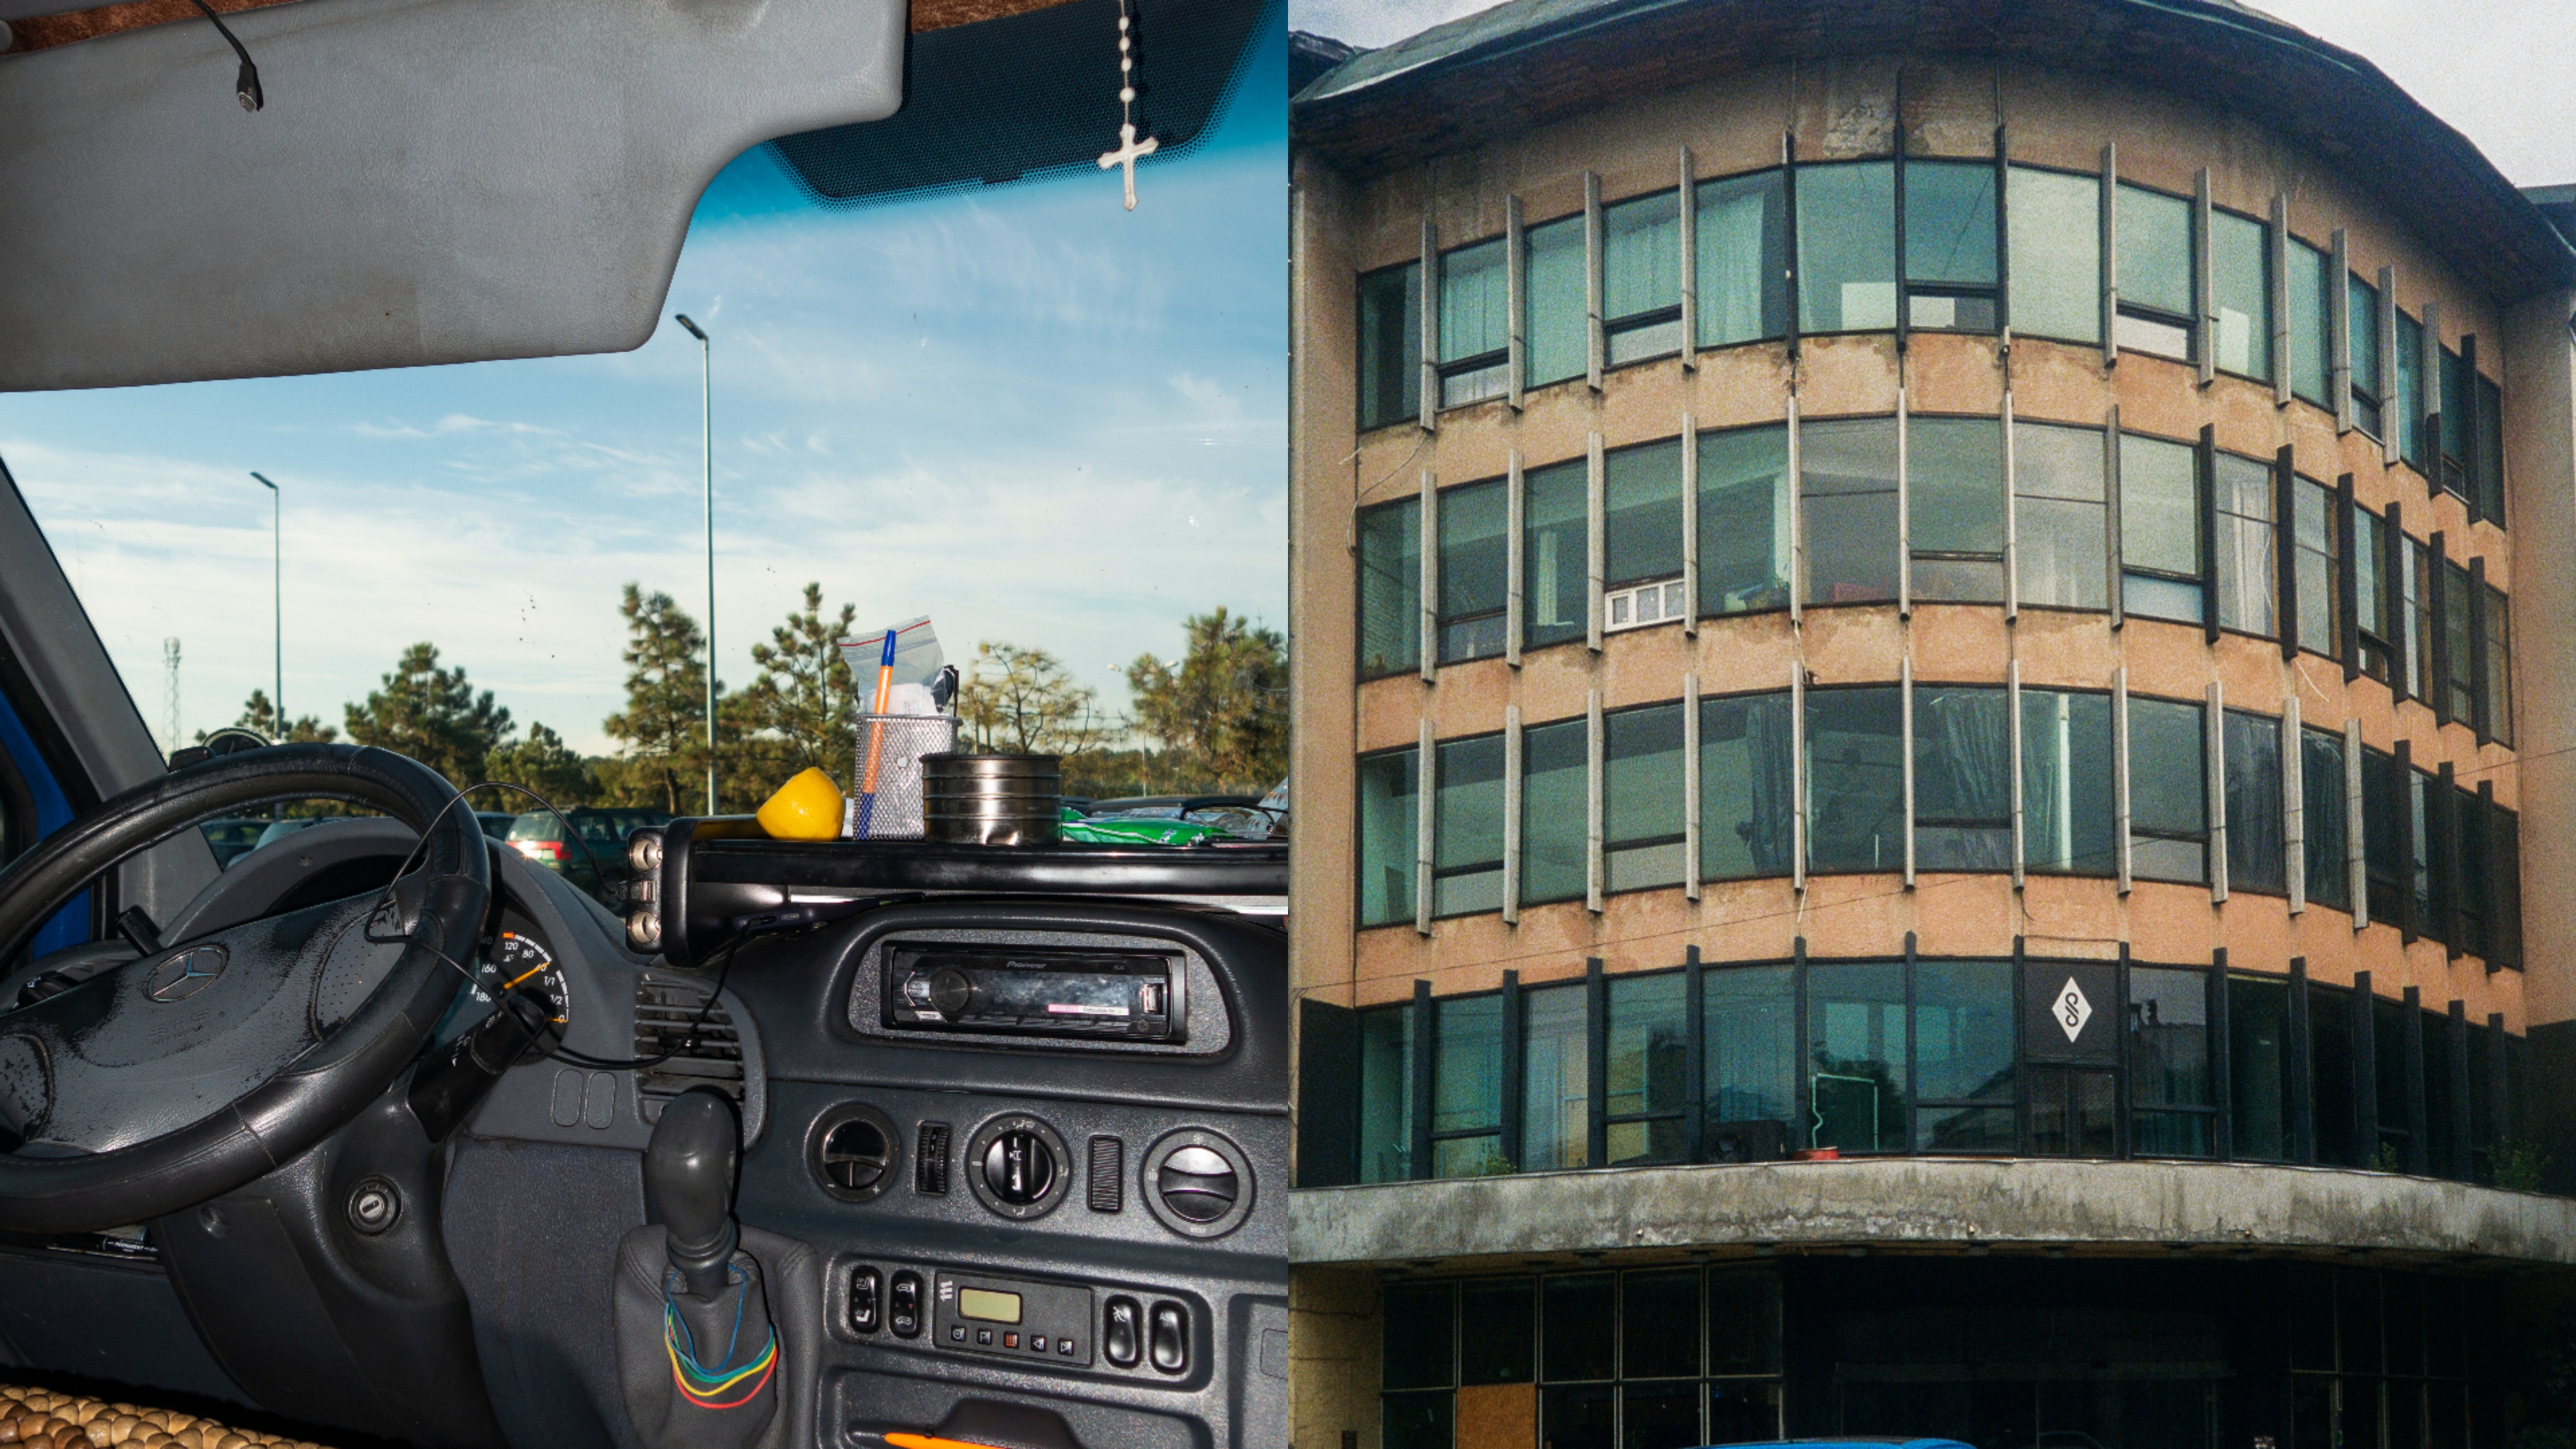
[1293,0,2576,1449]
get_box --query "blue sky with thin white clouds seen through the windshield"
[0,14,1288,750]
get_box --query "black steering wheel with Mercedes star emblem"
[0,745,492,1232]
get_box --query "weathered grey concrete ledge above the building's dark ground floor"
[1288,1158,2576,1266]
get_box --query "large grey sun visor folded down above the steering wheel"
[0,0,904,389]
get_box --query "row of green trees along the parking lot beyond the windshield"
[199,583,1288,815]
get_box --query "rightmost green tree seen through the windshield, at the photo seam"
[1128,606,1288,789]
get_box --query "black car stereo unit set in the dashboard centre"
[883,941,1190,1044]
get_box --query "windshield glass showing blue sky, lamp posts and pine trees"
[0,28,1288,814]
